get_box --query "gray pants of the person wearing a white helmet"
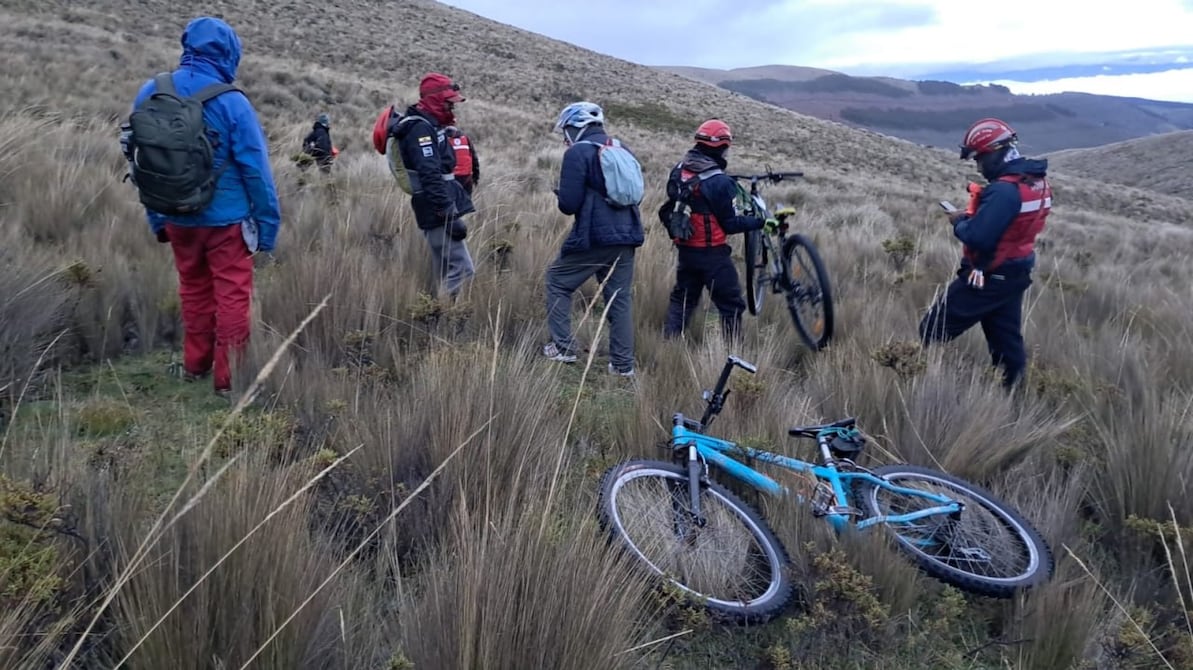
[546,247,635,371]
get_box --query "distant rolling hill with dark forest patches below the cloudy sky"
[661,66,1193,154]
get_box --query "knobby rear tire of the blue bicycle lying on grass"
[858,465,1055,597]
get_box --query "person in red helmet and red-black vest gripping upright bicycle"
[659,119,777,339]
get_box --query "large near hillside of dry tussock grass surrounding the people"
[7,0,1193,670]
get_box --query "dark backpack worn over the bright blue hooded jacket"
[125,73,243,216]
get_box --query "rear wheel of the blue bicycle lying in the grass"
[861,465,1053,597]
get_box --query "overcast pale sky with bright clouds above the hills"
[444,0,1193,95]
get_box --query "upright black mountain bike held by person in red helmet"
[729,169,833,350]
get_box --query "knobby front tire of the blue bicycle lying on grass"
[598,460,795,624]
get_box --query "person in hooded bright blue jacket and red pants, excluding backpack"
[132,17,282,396]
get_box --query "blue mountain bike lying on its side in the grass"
[598,356,1055,622]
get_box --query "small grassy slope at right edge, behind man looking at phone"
[1047,130,1193,198]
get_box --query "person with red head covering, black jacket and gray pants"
[394,73,476,297]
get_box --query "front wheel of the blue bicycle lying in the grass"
[599,460,793,622]
